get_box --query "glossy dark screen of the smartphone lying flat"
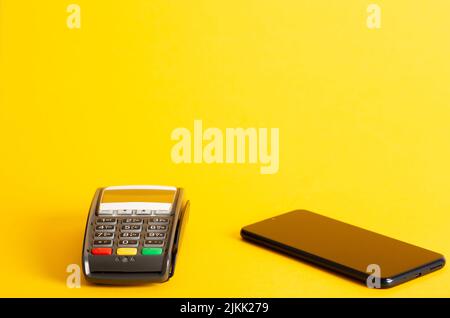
[243,210,443,277]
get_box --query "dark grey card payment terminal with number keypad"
[82,185,189,285]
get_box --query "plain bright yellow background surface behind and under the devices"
[0,0,450,297]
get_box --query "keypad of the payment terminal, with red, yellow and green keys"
[90,210,172,256]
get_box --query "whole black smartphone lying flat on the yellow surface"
[241,210,445,288]
